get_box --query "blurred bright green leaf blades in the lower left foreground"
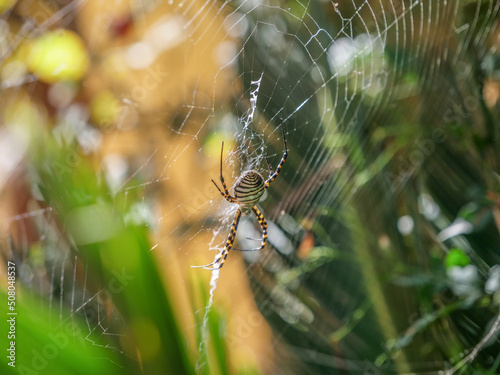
[1,134,228,375]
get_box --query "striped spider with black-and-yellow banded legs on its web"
[191,124,288,271]
